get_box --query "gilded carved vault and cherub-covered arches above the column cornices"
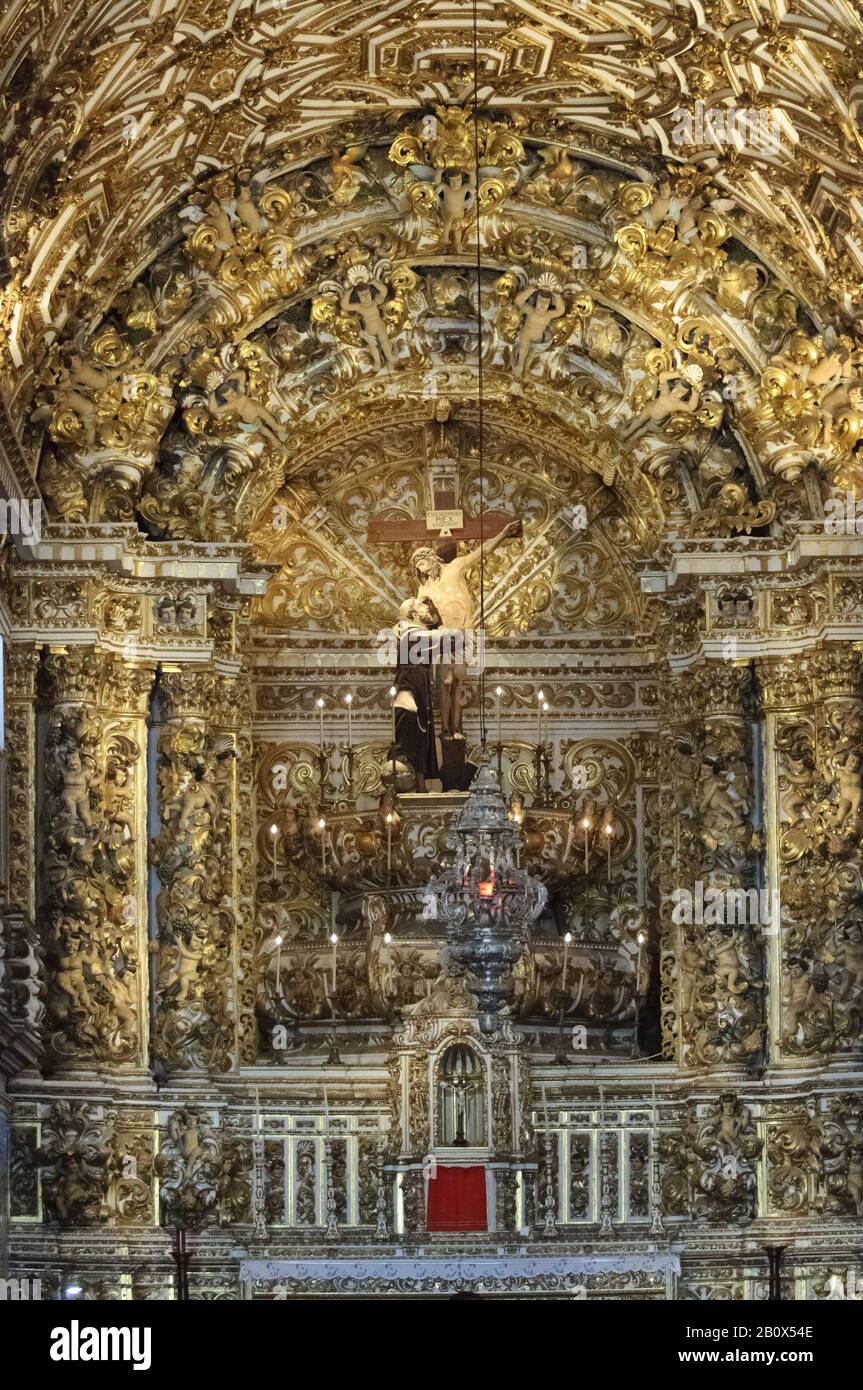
[0,0,863,631]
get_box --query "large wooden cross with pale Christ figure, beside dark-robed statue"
[368,400,521,791]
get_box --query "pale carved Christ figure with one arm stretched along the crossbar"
[410,521,518,738]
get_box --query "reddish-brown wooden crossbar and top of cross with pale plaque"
[368,405,521,560]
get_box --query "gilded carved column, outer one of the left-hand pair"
[40,646,146,1068]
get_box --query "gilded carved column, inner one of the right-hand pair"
[660,664,763,1068]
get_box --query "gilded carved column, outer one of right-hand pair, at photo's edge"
[759,646,863,1062]
